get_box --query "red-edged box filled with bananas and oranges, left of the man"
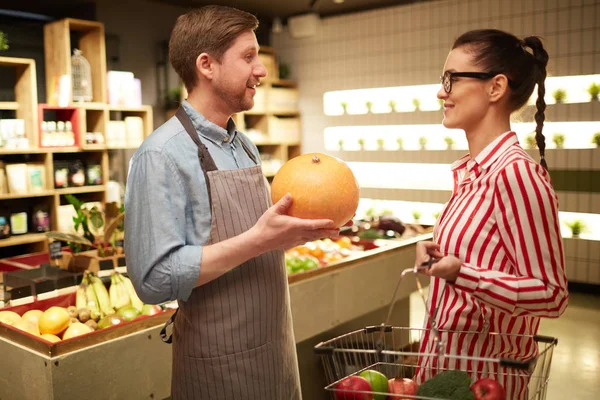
[0,271,173,357]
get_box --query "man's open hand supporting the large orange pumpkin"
[251,193,340,251]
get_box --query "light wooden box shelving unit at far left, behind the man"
[0,19,153,258]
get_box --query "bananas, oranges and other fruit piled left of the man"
[0,271,162,343]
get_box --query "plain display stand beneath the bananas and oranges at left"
[0,295,172,400]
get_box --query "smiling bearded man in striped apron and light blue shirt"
[125,6,338,400]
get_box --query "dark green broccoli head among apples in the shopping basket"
[417,371,475,400]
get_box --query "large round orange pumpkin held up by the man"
[271,153,360,227]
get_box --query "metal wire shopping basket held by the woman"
[314,260,557,400]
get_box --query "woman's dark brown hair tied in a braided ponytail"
[452,29,548,170]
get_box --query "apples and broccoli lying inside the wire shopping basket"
[334,369,506,400]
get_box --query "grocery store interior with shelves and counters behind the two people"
[0,0,600,400]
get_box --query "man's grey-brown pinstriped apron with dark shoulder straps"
[165,108,301,400]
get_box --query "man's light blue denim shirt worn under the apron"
[125,101,259,304]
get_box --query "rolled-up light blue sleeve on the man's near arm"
[125,149,202,304]
